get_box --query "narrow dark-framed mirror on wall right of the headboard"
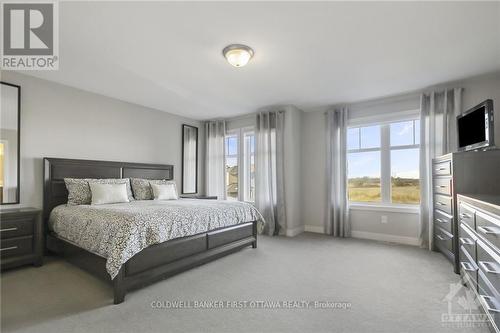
[182,125,198,194]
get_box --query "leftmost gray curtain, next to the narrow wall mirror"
[205,120,226,200]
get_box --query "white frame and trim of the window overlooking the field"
[346,110,422,212]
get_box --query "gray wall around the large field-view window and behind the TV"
[301,73,500,244]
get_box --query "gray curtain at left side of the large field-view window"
[324,107,351,237]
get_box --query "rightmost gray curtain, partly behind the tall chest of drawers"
[420,88,462,250]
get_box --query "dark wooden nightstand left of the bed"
[0,208,43,270]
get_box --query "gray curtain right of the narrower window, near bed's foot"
[255,111,286,236]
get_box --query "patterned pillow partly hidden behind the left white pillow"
[64,178,134,206]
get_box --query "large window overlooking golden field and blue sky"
[347,119,420,204]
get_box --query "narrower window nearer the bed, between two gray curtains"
[225,128,255,202]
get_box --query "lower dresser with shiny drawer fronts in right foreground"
[458,193,500,332]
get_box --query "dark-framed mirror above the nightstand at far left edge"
[0,82,21,205]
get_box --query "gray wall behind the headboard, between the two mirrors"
[2,71,204,208]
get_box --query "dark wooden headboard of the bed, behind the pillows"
[43,157,174,221]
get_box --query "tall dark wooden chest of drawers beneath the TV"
[432,149,500,274]
